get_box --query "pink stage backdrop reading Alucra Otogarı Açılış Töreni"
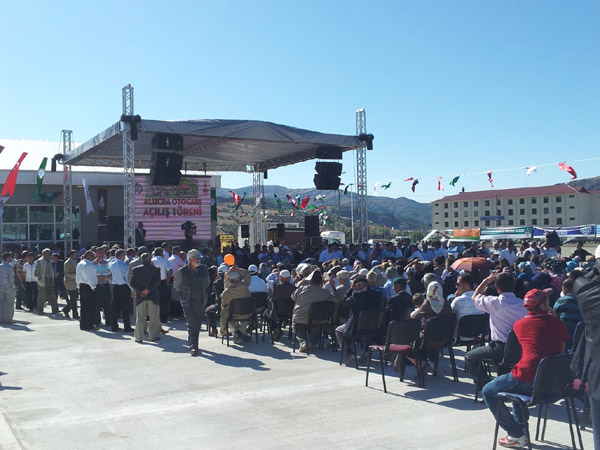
[135,175,211,241]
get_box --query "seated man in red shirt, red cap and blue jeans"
[482,288,569,448]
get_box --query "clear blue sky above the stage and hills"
[0,0,600,202]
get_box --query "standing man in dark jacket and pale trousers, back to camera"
[130,253,160,343]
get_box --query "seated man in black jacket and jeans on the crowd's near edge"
[335,278,381,366]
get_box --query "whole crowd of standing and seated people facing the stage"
[0,240,600,447]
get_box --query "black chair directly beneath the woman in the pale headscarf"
[415,316,458,386]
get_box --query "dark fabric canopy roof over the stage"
[64,119,361,172]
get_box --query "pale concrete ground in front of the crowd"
[0,308,593,450]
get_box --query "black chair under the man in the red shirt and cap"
[493,353,583,450]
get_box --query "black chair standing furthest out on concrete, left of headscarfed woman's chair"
[365,319,422,393]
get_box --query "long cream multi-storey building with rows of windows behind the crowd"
[431,184,600,230]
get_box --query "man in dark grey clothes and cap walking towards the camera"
[173,249,210,356]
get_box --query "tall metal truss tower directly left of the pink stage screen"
[121,84,137,248]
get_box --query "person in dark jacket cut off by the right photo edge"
[571,245,600,449]
